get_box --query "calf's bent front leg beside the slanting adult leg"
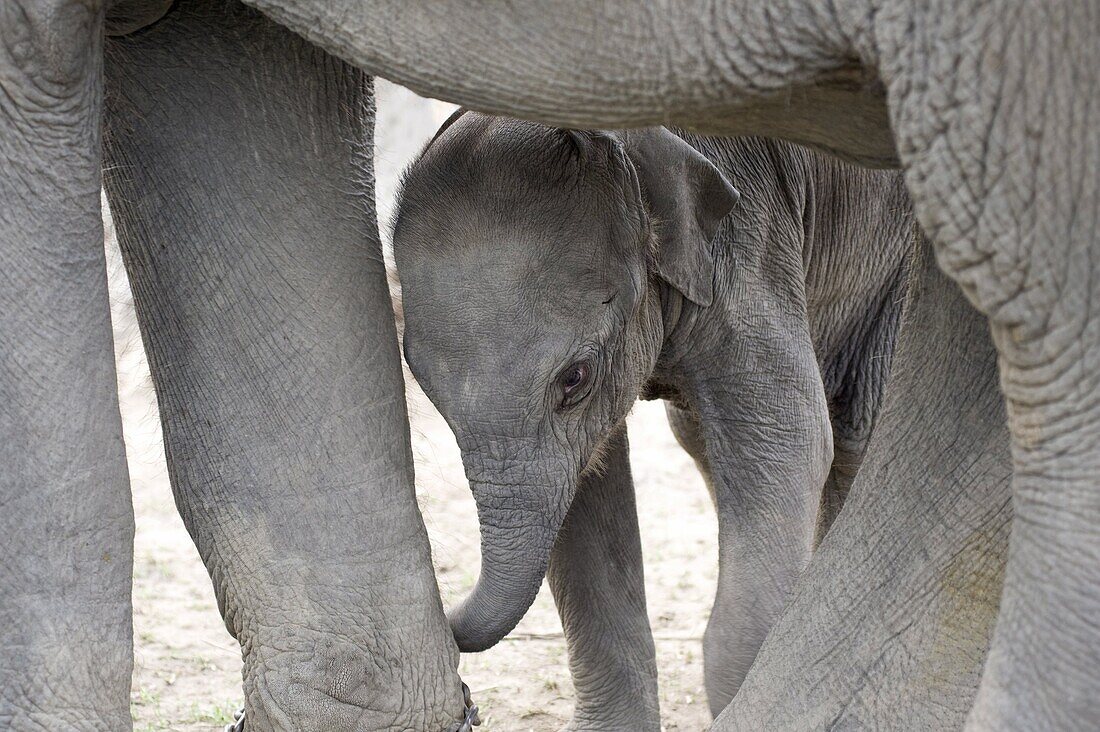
[684,306,833,715]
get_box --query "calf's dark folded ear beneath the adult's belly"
[616,127,740,307]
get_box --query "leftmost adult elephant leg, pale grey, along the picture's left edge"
[0,0,134,730]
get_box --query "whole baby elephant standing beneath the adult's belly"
[394,112,912,730]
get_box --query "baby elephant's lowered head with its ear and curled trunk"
[394,112,738,651]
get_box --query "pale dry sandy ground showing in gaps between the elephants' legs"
[108,84,717,732]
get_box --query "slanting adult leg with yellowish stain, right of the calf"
[714,236,1012,731]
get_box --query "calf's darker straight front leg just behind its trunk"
[549,427,661,732]
